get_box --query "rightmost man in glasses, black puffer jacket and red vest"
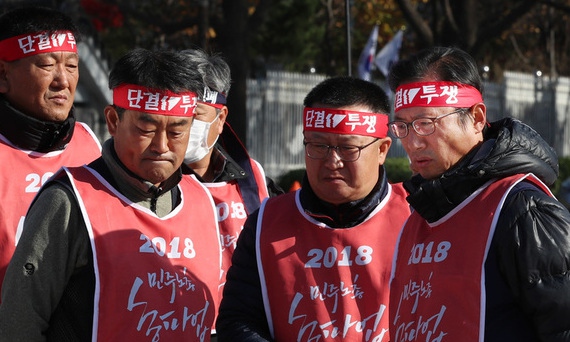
[389,47,570,342]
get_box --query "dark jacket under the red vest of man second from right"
[216,171,388,342]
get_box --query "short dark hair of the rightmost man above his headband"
[388,46,483,94]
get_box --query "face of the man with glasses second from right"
[304,107,391,205]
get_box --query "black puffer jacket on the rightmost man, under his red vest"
[404,119,570,342]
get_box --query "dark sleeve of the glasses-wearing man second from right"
[216,210,272,342]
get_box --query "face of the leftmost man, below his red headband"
[0,52,79,122]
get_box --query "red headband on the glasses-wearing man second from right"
[303,107,388,138]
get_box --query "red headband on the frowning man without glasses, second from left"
[113,84,197,116]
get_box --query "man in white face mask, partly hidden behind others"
[182,49,283,340]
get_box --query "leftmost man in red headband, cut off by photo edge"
[0,7,101,300]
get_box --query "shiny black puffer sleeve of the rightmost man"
[492,183,570,341]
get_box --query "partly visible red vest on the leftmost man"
[0,123,101,296]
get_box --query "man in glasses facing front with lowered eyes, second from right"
[216,77,410,341]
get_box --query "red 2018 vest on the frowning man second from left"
[64,167,221,341]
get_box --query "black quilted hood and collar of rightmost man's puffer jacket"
[404,118,558,222]
